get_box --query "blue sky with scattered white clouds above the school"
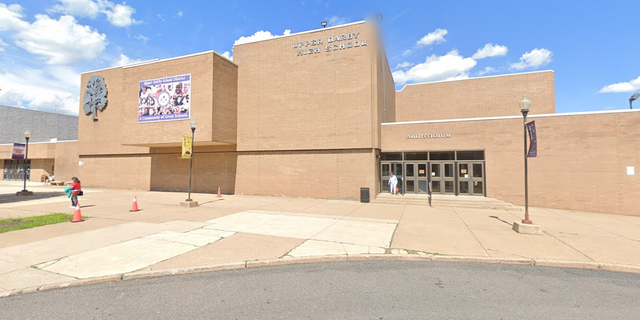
[0,0,640,114]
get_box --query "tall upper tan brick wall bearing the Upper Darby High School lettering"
[233,23,378,151]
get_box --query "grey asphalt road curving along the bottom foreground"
[0,261,640,320]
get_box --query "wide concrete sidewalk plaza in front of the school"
[0,182,640,296]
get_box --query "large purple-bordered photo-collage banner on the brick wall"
[138,74,191,123]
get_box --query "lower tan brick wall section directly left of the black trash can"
[236,150,379,200]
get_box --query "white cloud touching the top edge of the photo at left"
[49,0,140,28]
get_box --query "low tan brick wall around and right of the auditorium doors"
[382,112,640,216]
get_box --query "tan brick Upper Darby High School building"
[2,22,640,215]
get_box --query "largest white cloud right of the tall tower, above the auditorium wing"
[393,50,477,84]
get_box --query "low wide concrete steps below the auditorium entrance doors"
[371,193,519,210]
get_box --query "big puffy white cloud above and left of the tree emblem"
[15,15,107,65]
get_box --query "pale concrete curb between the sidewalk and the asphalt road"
[0,254,640,298]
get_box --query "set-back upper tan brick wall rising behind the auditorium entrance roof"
[396,71,556,122]
